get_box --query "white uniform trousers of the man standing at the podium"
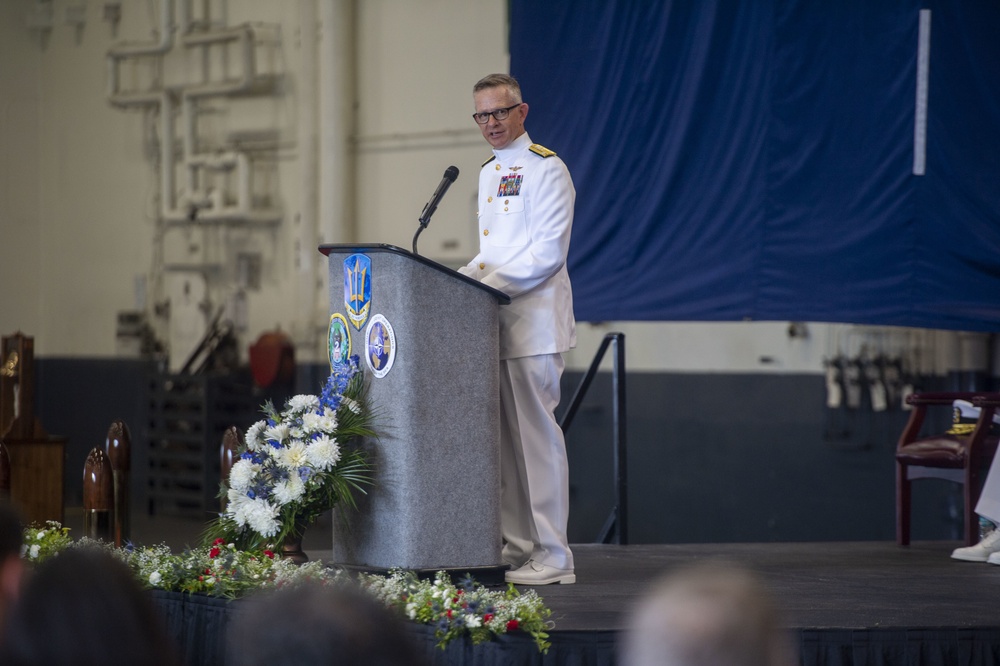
[500,353,573,569]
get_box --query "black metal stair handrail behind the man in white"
[559,333,628,545]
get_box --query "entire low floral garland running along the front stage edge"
[22,521,553,653]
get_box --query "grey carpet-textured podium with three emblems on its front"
[319,244,510,578]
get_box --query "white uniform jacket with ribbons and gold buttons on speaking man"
[459,133,576,360]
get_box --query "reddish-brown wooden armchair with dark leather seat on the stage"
[896,392,1000,546]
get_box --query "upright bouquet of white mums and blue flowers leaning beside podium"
[205,356,375,550]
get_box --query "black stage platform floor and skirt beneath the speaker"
[284,542,1000,666]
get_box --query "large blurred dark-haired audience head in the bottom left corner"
[0,546,178,666]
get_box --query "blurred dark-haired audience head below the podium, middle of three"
[226,584,426,666]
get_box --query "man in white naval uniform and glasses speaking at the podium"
[460,74,576,585]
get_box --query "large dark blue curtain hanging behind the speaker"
[510,0,1000,331]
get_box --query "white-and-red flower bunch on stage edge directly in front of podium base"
[359,571,552,653]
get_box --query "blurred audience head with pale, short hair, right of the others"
[621,563,795,666]
